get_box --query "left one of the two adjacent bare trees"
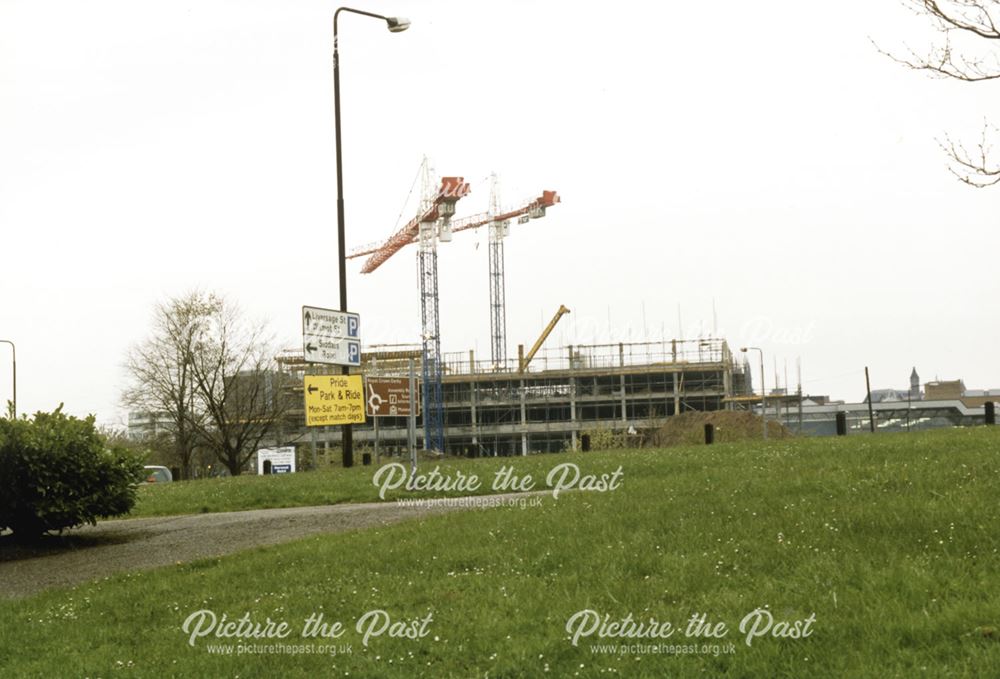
[121,291,222,478]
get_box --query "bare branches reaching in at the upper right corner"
[879,0,1000,188]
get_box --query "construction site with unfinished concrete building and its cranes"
[278,159,750,456]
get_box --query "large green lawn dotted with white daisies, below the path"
[0,428,1000,678]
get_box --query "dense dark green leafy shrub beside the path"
[0,406,142,540]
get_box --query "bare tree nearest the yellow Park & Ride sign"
[191,302,287,476]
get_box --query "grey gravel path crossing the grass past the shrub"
[0,493,534,599]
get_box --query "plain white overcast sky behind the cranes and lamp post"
[0,0,1000,422]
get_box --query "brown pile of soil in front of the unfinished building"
[647,410,794,448]
